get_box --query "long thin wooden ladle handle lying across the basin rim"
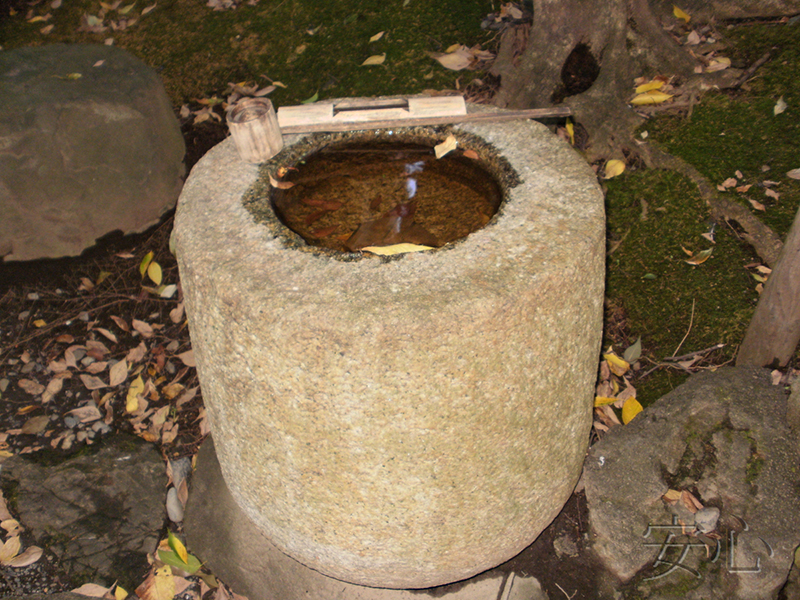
[278,106,572,134]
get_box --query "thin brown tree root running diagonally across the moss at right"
[641,143,783,267]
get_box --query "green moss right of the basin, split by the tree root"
[606,25,800,405]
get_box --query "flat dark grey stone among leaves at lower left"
[2,434,167,589]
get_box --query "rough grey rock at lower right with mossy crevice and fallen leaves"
[584,368,800,600]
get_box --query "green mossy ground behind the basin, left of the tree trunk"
[0,0,494,106]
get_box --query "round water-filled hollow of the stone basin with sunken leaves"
[270,140,503,252]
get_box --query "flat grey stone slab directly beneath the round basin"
[184,436,548,600]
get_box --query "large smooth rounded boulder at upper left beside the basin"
[0,44,185,260]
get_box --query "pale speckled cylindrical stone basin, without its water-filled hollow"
[174,107,605,588]
